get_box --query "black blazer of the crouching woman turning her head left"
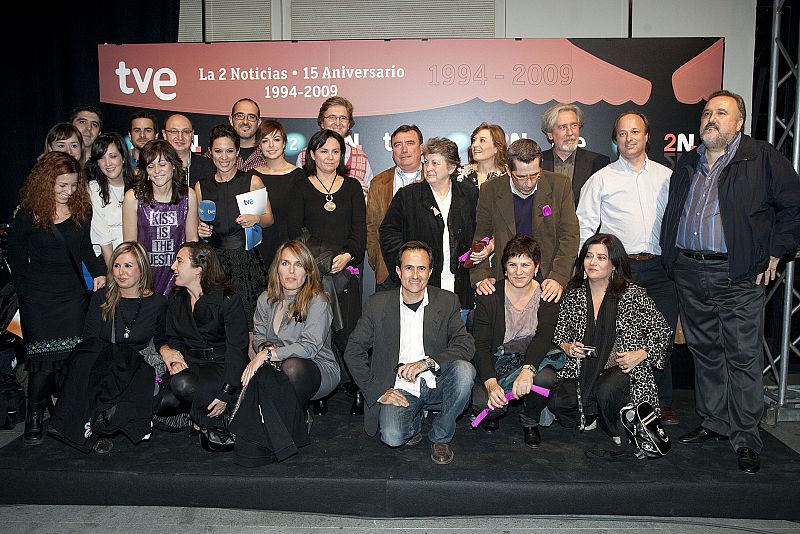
[167,287,249,402]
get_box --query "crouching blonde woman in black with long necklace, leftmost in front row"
[50,241,167,453]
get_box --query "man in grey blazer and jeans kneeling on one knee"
[344,241,475,464]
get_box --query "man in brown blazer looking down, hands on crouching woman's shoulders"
[470,139,579,302]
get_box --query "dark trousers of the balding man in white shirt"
[630,256,678,404]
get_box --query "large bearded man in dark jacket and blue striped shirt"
[661,91,800,473]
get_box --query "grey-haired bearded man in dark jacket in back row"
[542,102,611,206]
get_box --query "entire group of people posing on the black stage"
[9,91,800,473]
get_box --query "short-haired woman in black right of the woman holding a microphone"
[252,119,306,272]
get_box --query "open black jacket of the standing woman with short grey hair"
[378,179,478,310]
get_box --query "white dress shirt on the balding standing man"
[576,158,672,255]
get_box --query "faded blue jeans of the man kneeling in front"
[379,360,475,447]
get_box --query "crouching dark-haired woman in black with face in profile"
[156,241,247,452]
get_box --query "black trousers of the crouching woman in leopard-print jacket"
[547,366,631,437]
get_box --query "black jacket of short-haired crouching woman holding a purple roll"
[472,283,560,383]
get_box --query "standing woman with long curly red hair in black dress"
[8,152,106,445]
